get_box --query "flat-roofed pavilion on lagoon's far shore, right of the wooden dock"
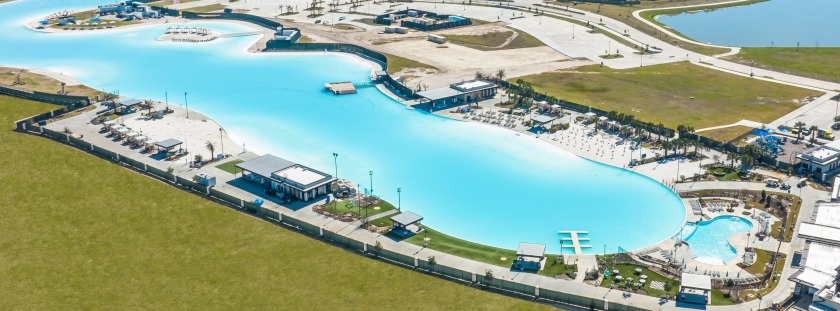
[417,80,499,110]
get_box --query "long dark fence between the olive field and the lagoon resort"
[16,100,656,311]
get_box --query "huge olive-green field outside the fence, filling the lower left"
[0,97,548,310]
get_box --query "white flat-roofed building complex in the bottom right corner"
[790,203,840,311]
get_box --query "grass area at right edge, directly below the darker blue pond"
[728,47,840,82]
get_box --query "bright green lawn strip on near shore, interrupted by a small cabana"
[404,226,577,277]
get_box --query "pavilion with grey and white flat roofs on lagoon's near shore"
[235,154,336,201]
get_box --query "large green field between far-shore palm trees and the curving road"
[522,62,820,129]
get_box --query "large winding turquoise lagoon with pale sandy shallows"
[0,0,685,253]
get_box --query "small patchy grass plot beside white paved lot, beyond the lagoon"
[445,29,545,51]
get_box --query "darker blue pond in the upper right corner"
[657,0,840,47]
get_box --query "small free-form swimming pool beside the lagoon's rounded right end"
[683,216,752,262]
